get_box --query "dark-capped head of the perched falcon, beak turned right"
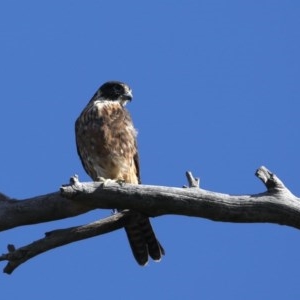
[93,81,132,106]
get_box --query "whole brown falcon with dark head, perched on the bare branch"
[75,81,164,266]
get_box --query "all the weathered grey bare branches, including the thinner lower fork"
[0,167,300,274]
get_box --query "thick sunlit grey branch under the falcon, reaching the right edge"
[61,167,300,229]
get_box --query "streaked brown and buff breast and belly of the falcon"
[76,101,137,180]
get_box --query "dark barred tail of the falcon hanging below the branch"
[125,214,165,266]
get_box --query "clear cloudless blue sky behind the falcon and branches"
[0,0,300,300]
